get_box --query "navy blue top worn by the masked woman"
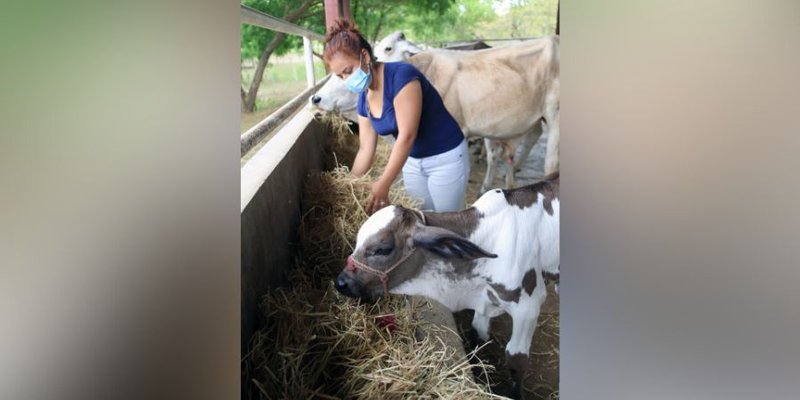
[357,62,464,158]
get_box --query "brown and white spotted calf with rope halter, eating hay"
[335,175,560,394]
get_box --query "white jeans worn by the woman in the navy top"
[403,139,469,212]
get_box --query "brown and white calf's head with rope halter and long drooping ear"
[335,206,497,299]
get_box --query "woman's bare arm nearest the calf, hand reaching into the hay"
[367,80,422,213]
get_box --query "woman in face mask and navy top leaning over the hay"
[323,20,469,214]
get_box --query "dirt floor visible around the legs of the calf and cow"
[455,135,560,400]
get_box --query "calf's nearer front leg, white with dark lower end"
[506,296,546,394]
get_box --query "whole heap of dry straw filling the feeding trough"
[243,113,498,399]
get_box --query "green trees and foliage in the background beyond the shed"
[240,0,558,111]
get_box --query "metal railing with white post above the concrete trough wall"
[240,5,325,156]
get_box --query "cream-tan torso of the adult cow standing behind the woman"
[409,37,559,138]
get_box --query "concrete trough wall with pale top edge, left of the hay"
[241,110,328,354]
